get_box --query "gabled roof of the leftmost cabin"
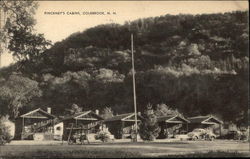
[20,108,56,119]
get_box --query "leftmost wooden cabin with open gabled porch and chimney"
[15,108,55,140]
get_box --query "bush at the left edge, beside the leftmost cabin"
[0,118,12,145]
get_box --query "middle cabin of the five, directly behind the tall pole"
[104,113,142,139]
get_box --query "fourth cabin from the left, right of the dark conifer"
[157,115,190,139]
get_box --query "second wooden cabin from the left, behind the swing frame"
[61,111,104,140]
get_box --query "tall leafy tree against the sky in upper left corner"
[0,1,50,61]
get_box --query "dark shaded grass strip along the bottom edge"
[0,149,249,159]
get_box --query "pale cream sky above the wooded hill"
[1,1,248,66]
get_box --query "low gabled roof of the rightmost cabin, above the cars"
[188,115,223,124]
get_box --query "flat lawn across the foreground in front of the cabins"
[0,141,249,159]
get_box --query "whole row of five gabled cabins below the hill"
[15,108,222,140]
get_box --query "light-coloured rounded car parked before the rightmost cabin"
[187,129,216,140]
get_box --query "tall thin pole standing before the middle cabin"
[131,33,138,142]
